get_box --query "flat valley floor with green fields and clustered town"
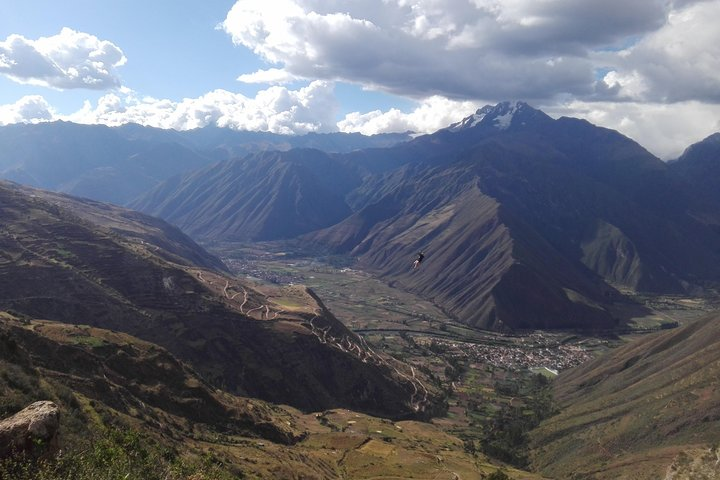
[211,242,719,472]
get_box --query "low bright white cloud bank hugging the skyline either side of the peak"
[0,86,720,160]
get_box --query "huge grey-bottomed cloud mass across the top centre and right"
[222,0,720,101]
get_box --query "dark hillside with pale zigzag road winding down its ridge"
[0,183,438,418]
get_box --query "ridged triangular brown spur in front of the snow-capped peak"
[316,142,615,329]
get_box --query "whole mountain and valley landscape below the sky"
[0,102,720,480]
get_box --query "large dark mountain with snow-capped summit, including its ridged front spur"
[306,104,720,328]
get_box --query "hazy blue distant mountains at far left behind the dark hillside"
[0,122,210,204]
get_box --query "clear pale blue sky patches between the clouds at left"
[0,0,414,116]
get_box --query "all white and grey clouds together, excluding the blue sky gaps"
[0,0,720,163]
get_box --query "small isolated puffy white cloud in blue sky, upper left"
[0,28,127,90]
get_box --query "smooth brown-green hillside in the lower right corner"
[533,314,720,480]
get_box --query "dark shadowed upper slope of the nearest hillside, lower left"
[0,313,301,443]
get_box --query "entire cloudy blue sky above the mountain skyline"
[0,0,720,159]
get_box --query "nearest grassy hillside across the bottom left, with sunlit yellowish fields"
[0,311,539,480]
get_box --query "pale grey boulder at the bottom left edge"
[0,400,60,458]
